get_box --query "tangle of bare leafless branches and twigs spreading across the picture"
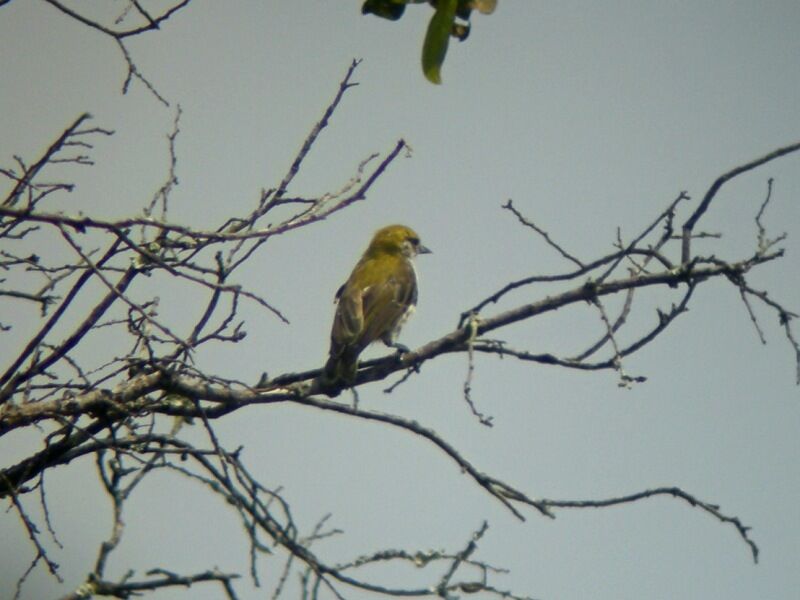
[0,38,800,600]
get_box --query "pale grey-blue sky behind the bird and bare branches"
[0,0,800,600]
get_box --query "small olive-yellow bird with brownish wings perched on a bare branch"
[323,225,431,386]
